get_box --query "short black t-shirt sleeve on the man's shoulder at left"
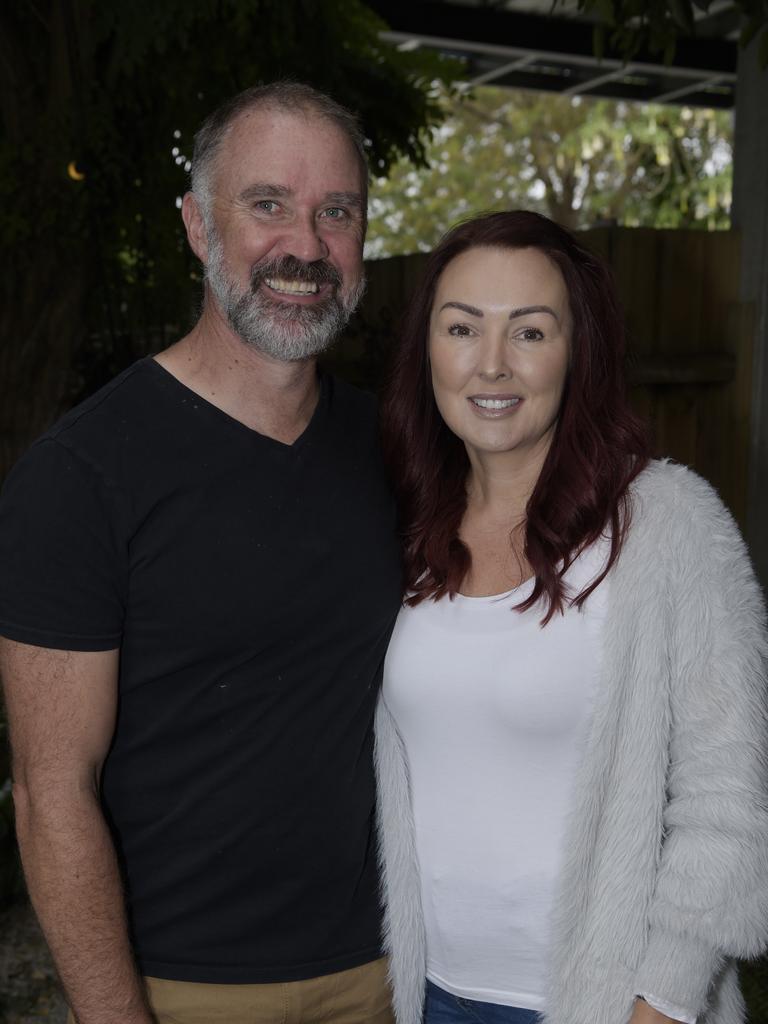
[0,438,126,650]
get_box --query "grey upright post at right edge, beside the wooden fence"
[732,40,768,590]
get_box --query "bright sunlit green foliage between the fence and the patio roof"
[368,87,732,257]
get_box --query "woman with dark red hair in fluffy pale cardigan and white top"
[377,212,768,1024]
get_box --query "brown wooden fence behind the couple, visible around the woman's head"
[333,228,753,528]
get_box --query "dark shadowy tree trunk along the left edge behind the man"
[0,0,90,479]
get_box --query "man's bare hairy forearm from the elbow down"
[14,787,153,1024]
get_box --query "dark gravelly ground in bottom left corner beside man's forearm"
[0,903,67,1024]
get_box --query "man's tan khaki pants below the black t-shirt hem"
[68,958,394,1024]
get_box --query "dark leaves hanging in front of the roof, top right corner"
[552,0,768,68]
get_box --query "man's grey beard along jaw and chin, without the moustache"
[205,231,366,362]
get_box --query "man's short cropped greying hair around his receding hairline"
[190,81,369,217]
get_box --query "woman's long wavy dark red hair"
[382,210,648,624]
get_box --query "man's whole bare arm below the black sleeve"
[0,638,153,1024]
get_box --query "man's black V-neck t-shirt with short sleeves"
[0,359,400,983]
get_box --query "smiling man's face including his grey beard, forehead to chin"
[198,110,365,360]
